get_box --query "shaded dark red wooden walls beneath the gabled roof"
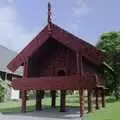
[28,38,102,77]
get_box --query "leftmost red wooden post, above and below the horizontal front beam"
[21,60,28,113]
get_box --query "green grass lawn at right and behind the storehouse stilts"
[0,95,120,120]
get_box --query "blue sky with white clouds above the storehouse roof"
[0,0,120,52]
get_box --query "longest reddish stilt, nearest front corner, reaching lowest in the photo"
[79,89,84,120]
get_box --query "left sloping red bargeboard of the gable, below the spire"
[7,26,48,72]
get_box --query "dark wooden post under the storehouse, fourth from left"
[60,90,66,112]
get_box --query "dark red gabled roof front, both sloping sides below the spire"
[8,24,105,72]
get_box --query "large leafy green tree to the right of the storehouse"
[96,32,120,100]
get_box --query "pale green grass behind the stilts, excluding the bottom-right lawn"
[0,95,79,112]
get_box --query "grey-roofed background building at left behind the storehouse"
[0,45,22,100]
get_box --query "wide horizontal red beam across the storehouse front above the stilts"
[12,75,96,90]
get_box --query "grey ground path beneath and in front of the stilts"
[0,110,80,120]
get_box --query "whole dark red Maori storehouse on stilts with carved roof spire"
[8,3,105,117]
